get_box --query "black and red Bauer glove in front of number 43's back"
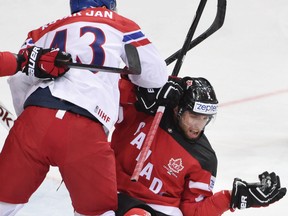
[18,46,72,78]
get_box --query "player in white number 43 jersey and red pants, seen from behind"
[0,0,168,216]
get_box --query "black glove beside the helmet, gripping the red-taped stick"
[135,80,183,115]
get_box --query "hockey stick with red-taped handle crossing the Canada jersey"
[130,0,207,182]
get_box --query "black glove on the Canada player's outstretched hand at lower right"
[230,172,286,210]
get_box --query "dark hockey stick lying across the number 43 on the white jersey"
[55,44,141,75]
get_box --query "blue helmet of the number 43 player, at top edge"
[70,0,117,14]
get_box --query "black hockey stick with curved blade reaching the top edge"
[165,0,226,68]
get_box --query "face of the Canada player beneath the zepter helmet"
[179,111,209,139]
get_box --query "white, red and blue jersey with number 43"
[8,8,168,130]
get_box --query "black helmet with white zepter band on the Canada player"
[178,77,218,118]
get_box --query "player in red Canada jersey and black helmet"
[112,77,286,216]
